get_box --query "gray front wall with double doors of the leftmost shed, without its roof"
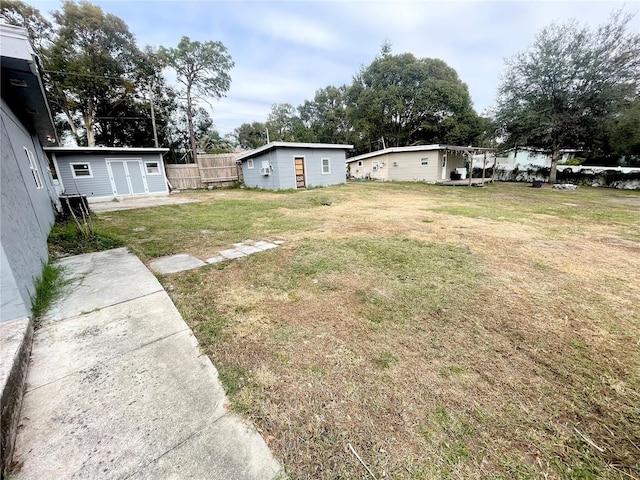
[51,152,169,200]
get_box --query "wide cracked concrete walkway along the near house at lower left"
[10,248,280,480]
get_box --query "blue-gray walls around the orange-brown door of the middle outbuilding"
[242,147,346,190]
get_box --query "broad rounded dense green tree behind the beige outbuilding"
[348,50,478,150]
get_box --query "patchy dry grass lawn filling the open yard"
[92,183,640,479]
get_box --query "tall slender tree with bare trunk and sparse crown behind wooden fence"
[160,37,234,162]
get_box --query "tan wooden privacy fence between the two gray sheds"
[165,153,242,189]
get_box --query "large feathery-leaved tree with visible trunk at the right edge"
[496,11,640,183]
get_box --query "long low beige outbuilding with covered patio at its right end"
[346,144,495,183]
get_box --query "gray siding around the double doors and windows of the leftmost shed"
[52,152,169,200]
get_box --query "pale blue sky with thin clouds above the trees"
[26,0,640,135]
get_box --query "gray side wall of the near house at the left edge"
[0,100,56,322]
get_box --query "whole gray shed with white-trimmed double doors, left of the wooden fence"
[45,147,169,202]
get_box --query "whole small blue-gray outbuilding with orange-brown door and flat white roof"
[236,142,353,190]
